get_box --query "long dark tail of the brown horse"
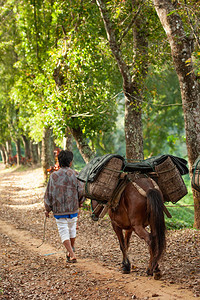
[147,189,166,268]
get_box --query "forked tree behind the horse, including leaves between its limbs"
[96,0,148,160]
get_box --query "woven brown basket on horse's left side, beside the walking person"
[85,157,123,203]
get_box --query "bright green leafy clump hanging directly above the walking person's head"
[46,37,120,138]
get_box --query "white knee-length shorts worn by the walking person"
[56,217,77,243]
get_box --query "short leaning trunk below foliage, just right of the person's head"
[71,128,95,163]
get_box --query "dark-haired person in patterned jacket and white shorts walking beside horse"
[44,150,84,262]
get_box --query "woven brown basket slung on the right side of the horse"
[155,157,187,203]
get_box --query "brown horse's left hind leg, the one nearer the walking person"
[112,223,131,274]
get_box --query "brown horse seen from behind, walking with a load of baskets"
[91,178,166,279]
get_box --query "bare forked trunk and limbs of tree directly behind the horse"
[96,0,148,161]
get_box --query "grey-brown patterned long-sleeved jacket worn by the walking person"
[44,167,84,215]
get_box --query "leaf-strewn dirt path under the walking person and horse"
[0,164,200,300]
